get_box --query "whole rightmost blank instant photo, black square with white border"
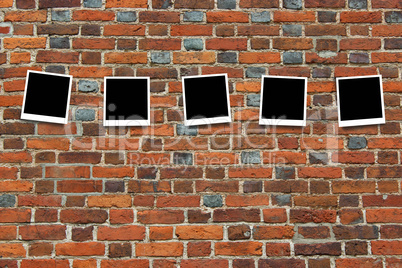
[336,75,385,127]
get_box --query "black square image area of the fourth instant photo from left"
[261,77,306,120]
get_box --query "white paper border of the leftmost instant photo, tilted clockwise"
[20,70,73,125]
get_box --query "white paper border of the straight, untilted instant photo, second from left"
[103,76,151,127]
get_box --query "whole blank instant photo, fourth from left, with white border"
[259,75,307,126]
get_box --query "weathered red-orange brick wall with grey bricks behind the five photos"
[0,0,402,268]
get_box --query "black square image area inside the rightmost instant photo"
[338,77,382,121]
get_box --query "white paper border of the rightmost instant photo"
[336,75,385,127]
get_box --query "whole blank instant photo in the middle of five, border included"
[182,74,231,126]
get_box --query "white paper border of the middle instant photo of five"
[182,73,232,126]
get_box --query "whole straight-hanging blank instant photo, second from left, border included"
[103,77,150,126]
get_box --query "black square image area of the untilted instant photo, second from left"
[105,78,148,120]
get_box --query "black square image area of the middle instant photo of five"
[184,75,229,120]
